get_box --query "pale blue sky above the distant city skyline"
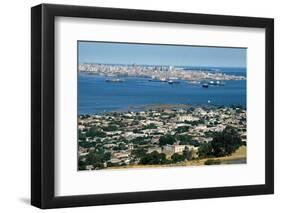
[78,41,247,67]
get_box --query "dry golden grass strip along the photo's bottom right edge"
[107,146,247,169]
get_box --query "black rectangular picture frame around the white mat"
[31,4,274,209]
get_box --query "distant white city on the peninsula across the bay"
[78,63,246,81]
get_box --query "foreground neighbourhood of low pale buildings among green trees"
[78,105,246,170]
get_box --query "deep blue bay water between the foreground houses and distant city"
[78,68,246,114]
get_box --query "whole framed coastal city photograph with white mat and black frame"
[31,4,274,208]
